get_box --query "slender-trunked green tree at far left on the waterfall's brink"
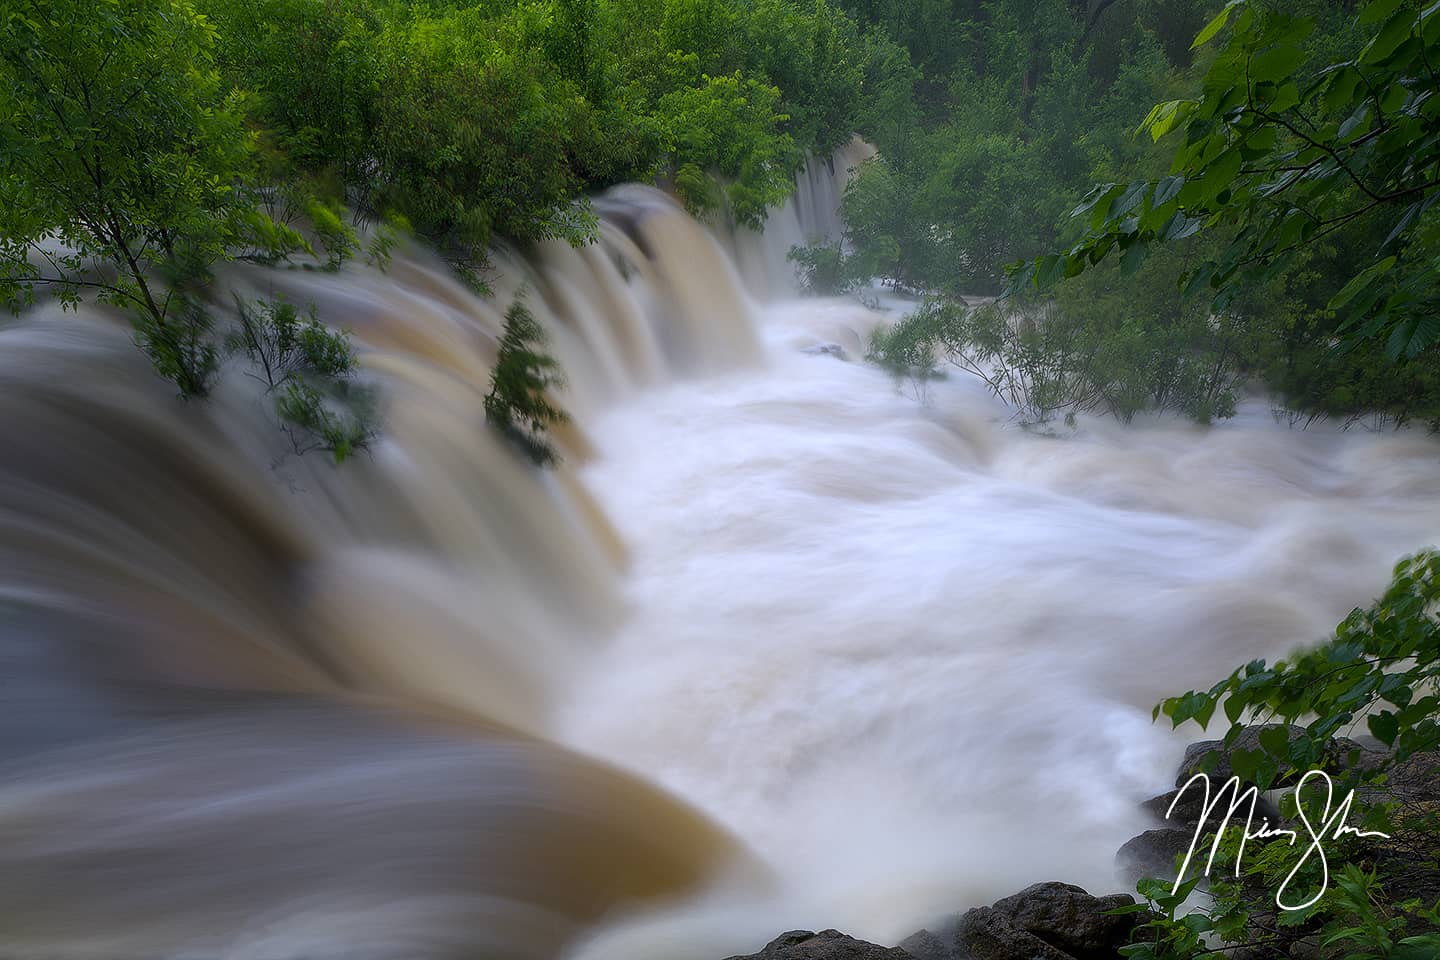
[0,0,269,394]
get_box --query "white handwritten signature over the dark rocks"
[1165,770,1390,910]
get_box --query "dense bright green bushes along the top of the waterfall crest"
[202,0,910,259]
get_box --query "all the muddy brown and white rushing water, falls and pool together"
[0,154,1440,960]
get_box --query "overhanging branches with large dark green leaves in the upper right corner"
[1012,0,1440,358]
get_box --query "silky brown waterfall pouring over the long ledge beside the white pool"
[0,187,777,959]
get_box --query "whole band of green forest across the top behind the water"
[0,0,1440,426]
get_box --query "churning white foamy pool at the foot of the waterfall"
[560,302,1440,956]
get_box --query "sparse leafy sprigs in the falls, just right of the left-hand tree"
[229,299,374,463]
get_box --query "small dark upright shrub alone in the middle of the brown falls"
[485,301,569,466]
